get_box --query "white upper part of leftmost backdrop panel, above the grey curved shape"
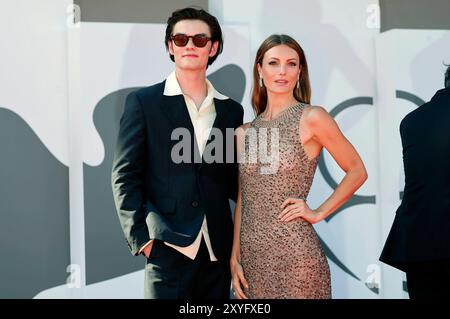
[0,0,72,165]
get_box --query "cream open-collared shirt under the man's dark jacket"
[141,72,228,261]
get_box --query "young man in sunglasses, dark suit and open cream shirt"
[112,8,243,299]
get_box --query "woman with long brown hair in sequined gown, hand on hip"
[230,35,367,299]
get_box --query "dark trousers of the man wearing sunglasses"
[144,239,231,299]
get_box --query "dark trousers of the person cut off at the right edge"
[406,261,450,299]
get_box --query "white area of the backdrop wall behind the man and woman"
[0,0,450,298]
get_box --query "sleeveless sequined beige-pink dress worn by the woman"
[239,103,331,299]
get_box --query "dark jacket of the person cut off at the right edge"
[380,88,450,271]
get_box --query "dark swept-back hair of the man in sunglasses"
[165,7,223,65]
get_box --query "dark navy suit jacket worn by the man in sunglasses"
[112,81,243,260]
